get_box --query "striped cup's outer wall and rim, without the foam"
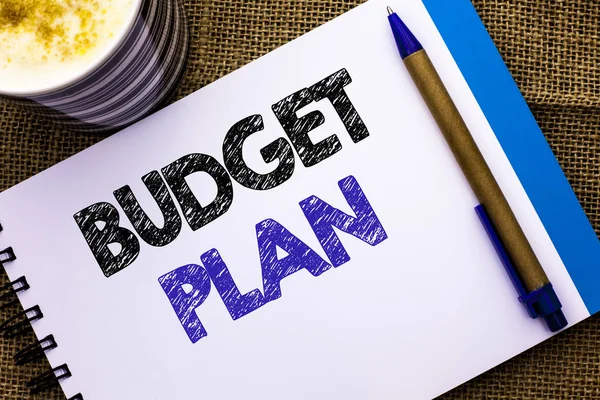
[0,0,189,133]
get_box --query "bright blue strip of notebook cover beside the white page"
[423,0,600,314]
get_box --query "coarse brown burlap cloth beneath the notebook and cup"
[0,0,600,400]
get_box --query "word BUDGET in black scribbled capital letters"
[74,69,369,277]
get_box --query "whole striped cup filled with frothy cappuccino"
[0,0,189,132]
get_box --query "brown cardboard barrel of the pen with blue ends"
[404,50,549,292]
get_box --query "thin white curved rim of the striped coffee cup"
[0,0,144,97]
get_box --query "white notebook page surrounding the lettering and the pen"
[0,0,588,400]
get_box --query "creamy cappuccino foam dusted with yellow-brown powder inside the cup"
[0,0,138,94]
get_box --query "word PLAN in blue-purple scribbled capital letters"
[158,176,387,343]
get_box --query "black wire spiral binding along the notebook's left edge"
[0,241,83,400]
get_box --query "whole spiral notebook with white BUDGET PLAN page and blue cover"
[0,0,600,400]
